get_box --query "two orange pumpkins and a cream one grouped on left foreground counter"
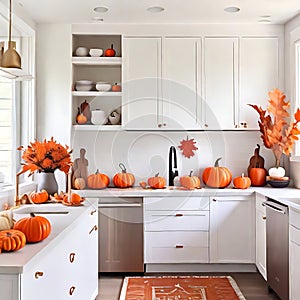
[0,210,51,253]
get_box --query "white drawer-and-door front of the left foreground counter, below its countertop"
[19,207,98,300]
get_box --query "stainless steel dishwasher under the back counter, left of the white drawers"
[98,197,144,273]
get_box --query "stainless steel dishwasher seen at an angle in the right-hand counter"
[263,198,289,300]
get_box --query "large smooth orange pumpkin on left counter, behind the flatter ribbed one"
[14,213,51,243]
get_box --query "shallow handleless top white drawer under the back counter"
[144,197,209,211]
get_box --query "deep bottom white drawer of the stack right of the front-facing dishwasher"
[145,231,208,263]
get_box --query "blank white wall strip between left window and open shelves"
[36,24,72,144]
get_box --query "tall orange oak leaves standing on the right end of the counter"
[249,89,300,172]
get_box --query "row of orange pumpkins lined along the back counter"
[74,158,265,190]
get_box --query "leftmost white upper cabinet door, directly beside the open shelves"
[122,37,162,129]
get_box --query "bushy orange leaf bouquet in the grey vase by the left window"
[18,137,72,176]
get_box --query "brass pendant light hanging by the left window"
[1,0,21,69]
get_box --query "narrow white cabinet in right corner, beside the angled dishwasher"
[256,195,267,280]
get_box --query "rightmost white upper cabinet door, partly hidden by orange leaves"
[239,37,281,128]
